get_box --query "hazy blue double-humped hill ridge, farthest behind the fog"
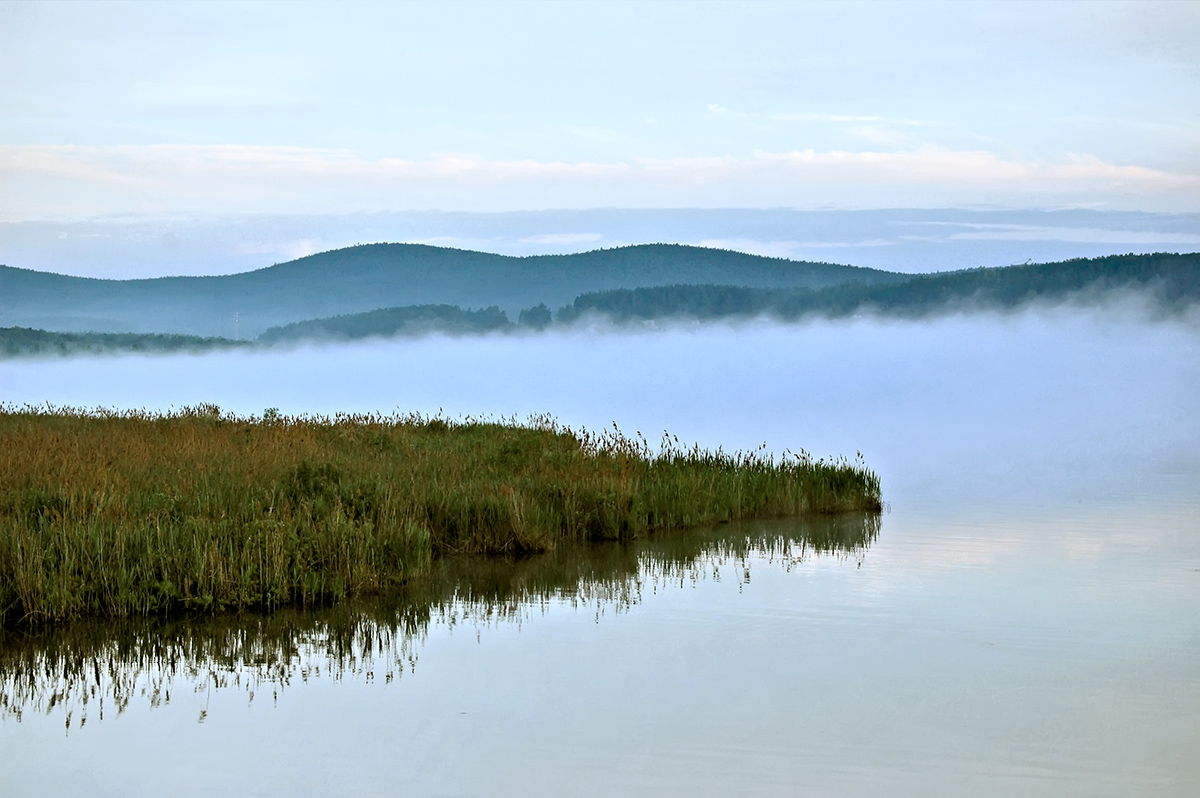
[0,244,907,338]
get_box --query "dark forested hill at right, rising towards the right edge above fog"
[556,253,1200,323]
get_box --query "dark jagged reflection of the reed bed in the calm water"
[0,515,881,732]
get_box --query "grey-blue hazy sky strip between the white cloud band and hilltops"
[0,208,1200,280]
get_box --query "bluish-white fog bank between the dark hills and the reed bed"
[0,306,1200,510]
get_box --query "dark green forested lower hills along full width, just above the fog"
[0,251,1200,358]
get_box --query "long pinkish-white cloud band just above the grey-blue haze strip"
[0,145,1200,220]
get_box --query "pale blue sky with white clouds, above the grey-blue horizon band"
[0,2,1200,220]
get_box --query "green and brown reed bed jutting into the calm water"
[0,406,881,628]
